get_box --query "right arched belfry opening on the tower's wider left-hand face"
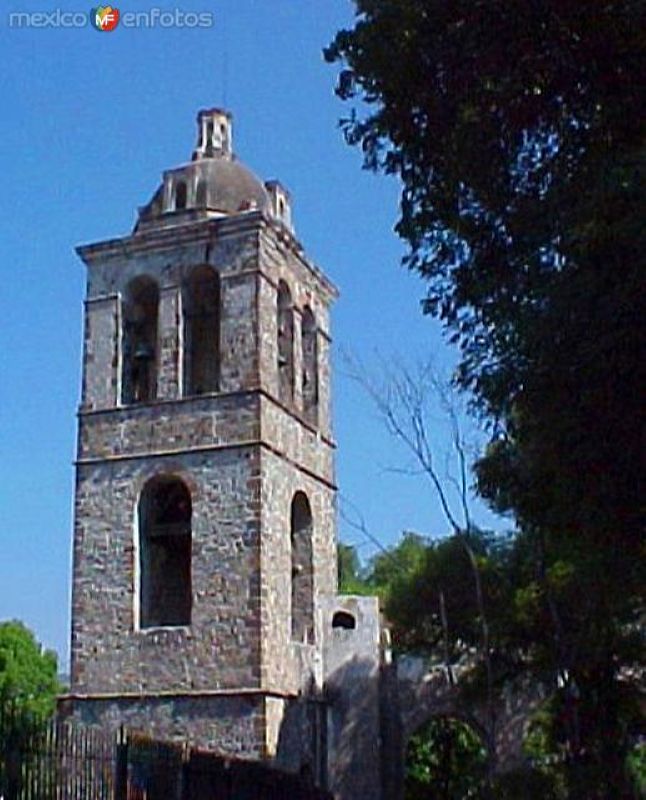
[184,267,220,395]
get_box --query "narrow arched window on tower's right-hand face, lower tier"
[290,492,314,643]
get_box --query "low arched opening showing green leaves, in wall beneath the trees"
[404,717,488,800]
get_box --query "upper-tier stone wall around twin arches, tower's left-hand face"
[79,220,259,410]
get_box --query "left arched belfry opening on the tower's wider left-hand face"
[121,277,159,403]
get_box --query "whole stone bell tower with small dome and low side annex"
[67,109,382,800]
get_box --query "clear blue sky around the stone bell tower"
[0,0,504,668]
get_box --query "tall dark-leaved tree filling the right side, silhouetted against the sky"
[326,0,646,798]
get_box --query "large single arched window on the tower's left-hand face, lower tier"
[139,477,192,628]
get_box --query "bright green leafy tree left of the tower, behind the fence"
[0,621,60,721]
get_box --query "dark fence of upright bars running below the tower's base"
[0,710,332,800]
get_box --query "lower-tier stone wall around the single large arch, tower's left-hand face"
[72,447,260,693]
